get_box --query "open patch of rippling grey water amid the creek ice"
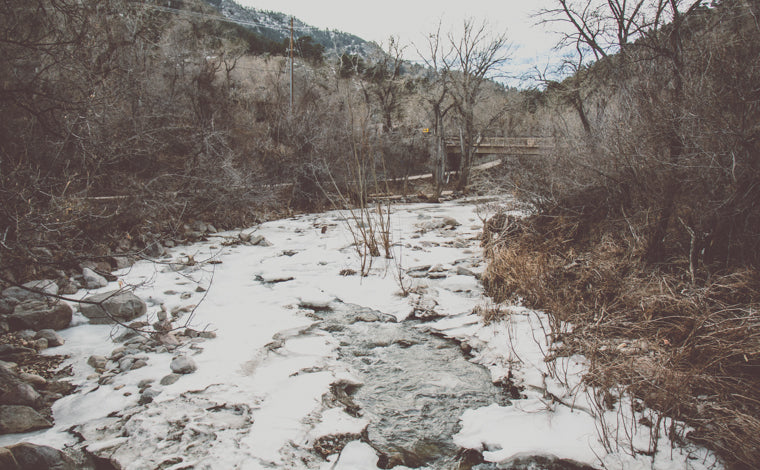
[317,304,509,469]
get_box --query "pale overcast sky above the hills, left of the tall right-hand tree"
[237,0,557,83]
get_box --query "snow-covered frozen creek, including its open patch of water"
[0,201,720,470]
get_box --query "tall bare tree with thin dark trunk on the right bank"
[542,0,704,262]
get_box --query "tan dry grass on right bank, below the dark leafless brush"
[483,211,760,469]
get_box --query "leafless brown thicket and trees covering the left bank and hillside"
[0,0,520,283]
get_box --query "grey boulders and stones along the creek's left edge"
[0,223,256,469]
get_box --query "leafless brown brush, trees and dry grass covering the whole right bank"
[484,0,760,468]
